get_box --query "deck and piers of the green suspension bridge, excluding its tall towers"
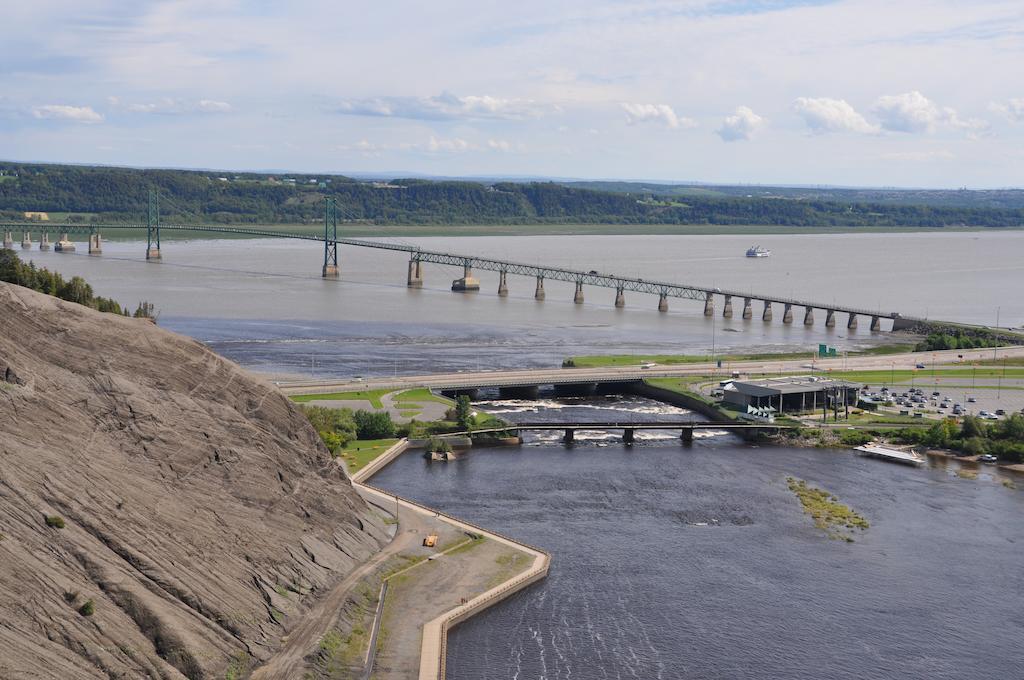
[6,222,905,323]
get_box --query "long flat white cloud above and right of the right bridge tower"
[337,92,558,120]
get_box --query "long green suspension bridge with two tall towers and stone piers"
[0,192,921,331]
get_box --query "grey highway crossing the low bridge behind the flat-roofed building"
[276,346,1024,394]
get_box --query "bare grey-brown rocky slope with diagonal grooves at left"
[0,284,386,678]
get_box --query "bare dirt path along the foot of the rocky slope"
[251,499,427,680]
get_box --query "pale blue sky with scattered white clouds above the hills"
[0,0,1024,188]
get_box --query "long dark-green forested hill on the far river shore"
[0,163,1024,227]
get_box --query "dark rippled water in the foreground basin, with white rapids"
[374,398,1024,680]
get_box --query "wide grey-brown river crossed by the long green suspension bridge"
[24,231,1024,377]
